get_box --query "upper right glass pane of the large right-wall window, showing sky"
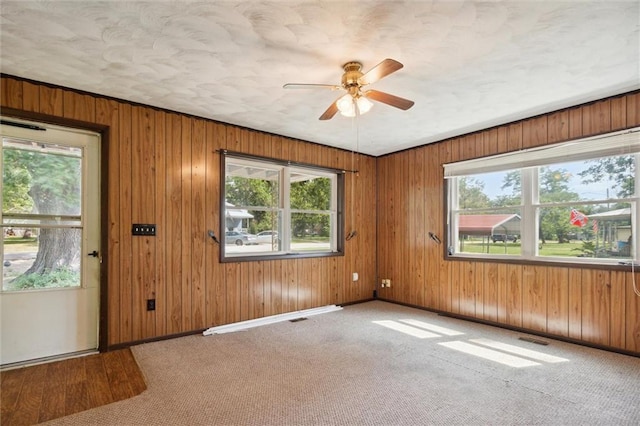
[539,155,635,202]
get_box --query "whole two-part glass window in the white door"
[2,137,83,291]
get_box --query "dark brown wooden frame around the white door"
[2,107,110,352]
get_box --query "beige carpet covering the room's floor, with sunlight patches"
[49,301,640,425]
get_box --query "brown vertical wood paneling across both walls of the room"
[5,76,640,353]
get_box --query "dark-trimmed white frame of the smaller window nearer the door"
[219,150,346,263]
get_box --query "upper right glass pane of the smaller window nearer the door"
[290,172,331,211]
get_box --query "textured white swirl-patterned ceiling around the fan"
[0,0,640,155]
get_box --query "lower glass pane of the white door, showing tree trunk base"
[2,228,81,291]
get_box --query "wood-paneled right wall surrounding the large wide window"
[377,93,640,353]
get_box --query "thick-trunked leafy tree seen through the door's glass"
[2,148,82,277]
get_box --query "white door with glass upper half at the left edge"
[0,118,101,366]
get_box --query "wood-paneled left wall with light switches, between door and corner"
[0,76,376,346]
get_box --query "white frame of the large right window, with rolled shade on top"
[443,127,640,267]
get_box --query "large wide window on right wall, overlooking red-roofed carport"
[444,129,640,264]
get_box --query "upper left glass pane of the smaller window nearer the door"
[225,161,280,207]
